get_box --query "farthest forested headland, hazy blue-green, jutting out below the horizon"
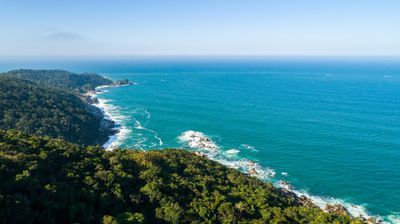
[2,69,113,92]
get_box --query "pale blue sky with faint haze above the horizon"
[0,0,400,57]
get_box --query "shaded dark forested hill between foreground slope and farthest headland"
[0,76,110,145]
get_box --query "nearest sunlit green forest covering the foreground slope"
[0,130,361,224]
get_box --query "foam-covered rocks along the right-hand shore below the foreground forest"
[178,130,387,224]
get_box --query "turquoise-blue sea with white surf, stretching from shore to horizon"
[0,57,400,223]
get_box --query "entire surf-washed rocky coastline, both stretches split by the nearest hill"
[85,76,387,224]
